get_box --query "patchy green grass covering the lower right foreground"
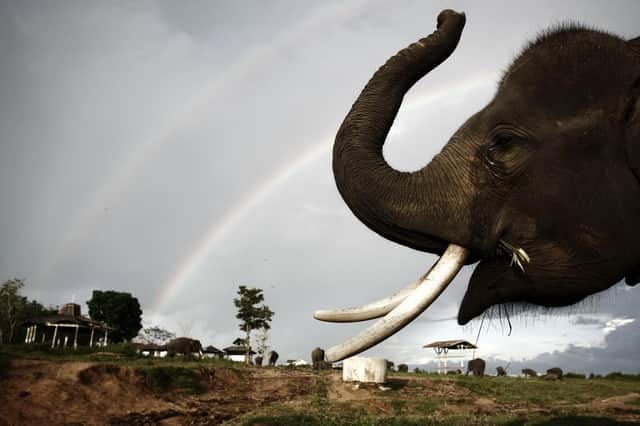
[237,373,640,426]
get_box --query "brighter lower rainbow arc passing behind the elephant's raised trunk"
[152,73,497,312]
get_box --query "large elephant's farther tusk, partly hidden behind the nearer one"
[313,267,433,322]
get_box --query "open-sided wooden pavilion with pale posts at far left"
[21,303,112,349]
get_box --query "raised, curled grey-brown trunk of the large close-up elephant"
[333,10,465,253]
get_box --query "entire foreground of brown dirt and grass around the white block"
[0,359,640,425]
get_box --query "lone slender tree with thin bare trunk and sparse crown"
[233,285,274,363]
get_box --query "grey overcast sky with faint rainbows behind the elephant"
[0,0,640,372]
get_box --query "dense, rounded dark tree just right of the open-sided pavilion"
[87,290,142,342]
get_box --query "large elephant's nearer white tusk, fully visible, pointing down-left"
[325,244,469,362]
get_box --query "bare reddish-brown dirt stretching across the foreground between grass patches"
[0,360,640,425]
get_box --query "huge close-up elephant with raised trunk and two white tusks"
[314,10,640,361]
